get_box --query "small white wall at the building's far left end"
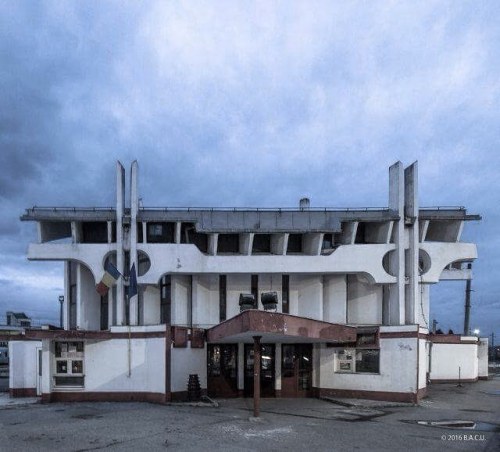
[9,341,42,389]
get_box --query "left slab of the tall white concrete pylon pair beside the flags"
[113,162,125,325]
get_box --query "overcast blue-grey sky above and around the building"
[0,0,500,342]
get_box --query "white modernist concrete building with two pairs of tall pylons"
[6,162,487,402]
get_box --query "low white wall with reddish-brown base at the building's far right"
[430,343,478,381]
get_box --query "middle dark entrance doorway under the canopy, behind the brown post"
[244,344,276,397]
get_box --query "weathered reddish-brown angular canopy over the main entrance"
[207,309,356,344]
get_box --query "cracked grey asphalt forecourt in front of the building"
[0,376,500,452]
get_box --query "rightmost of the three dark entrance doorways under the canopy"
[281,344,312,397]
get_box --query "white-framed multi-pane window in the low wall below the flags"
[54,341,84,387]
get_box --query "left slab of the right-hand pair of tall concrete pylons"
[389,162,405,325]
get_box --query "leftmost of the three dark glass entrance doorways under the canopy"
[207,344,238,397]
